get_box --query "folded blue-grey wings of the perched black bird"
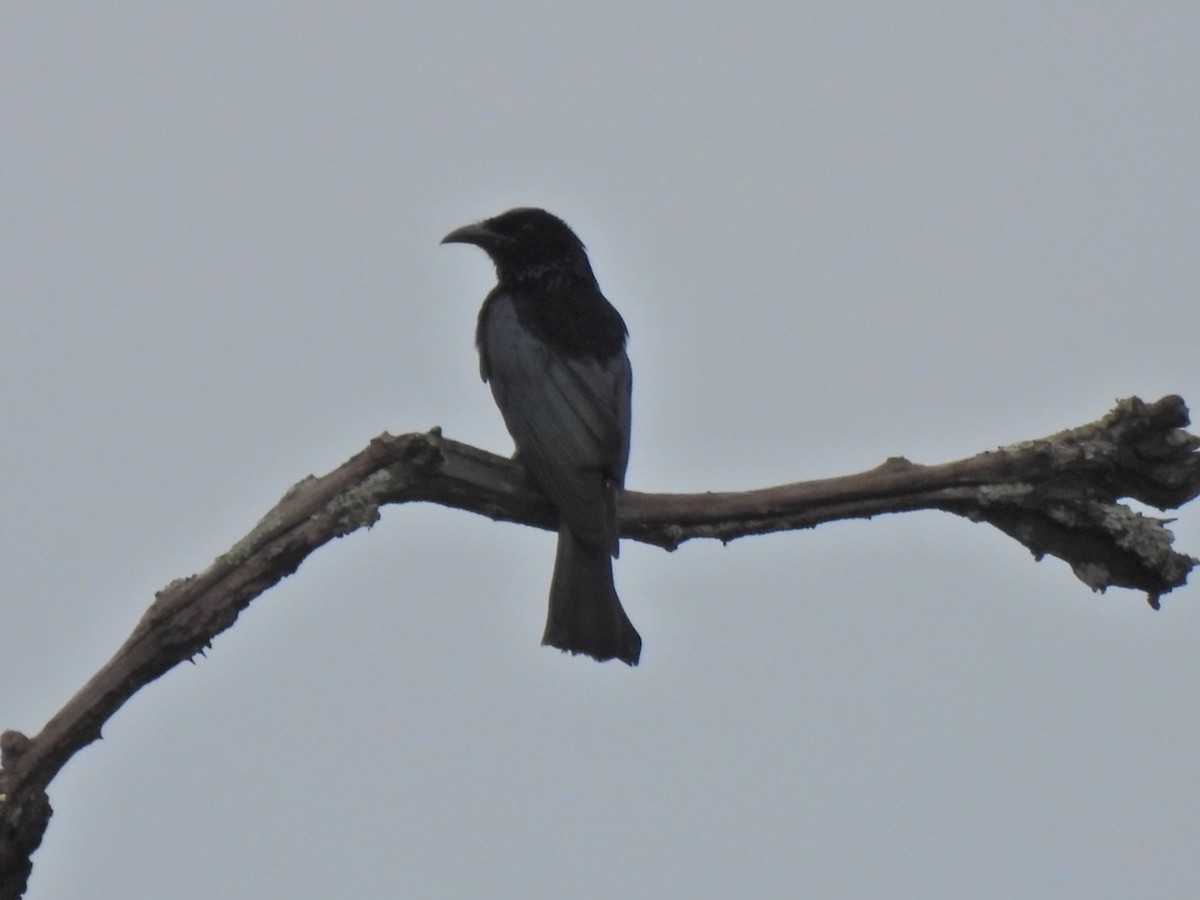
[481,296,631,547]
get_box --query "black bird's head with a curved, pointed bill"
[442,208,593,282]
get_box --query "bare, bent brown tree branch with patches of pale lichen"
[0,396,1200,900]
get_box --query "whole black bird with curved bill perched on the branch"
[442,209,642,666]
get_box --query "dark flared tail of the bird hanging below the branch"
[541,526,642,666]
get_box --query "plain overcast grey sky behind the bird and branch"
[0,2,1200,900]
